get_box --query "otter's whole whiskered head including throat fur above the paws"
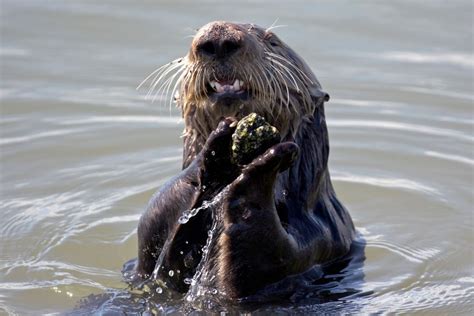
[141,21,327,166]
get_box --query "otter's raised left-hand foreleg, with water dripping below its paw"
[137,118,241,282]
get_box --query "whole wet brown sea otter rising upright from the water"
[137,21,355,299]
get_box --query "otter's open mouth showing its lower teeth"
[207,79,249,104]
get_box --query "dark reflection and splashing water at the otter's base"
[76,238,373,314]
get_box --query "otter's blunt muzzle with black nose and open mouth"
[188,22,265,107]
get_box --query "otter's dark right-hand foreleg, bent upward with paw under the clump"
[217,143,304,297]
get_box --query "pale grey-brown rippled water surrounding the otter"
[0,0,474,315]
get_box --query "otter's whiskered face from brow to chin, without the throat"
[180,22,319,132]
